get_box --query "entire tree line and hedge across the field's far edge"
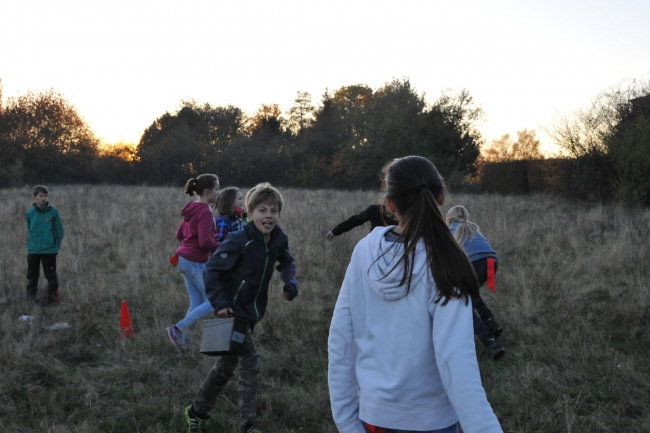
[0,79,650,205]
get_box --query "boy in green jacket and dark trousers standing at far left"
[26,185,63,304]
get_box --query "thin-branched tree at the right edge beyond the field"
[549,77,650,206]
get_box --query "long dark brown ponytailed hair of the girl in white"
[383,156,479,305]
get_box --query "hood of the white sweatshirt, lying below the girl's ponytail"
[359,227,430,301]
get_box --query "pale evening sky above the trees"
[0,0,650,152]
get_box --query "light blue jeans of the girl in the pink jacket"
[176,256,214,332]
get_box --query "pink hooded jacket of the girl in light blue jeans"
[176,201,218,263]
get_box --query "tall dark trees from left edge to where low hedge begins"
[0,79,483,189]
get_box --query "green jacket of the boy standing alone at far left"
[26,203,63,254]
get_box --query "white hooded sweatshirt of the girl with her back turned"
[328,227,502,433]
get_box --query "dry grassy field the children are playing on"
[0,186,650,433]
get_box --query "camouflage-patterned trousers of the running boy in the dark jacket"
[192,328,260,431]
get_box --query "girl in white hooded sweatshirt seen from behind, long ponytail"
[328,156,502,433]
